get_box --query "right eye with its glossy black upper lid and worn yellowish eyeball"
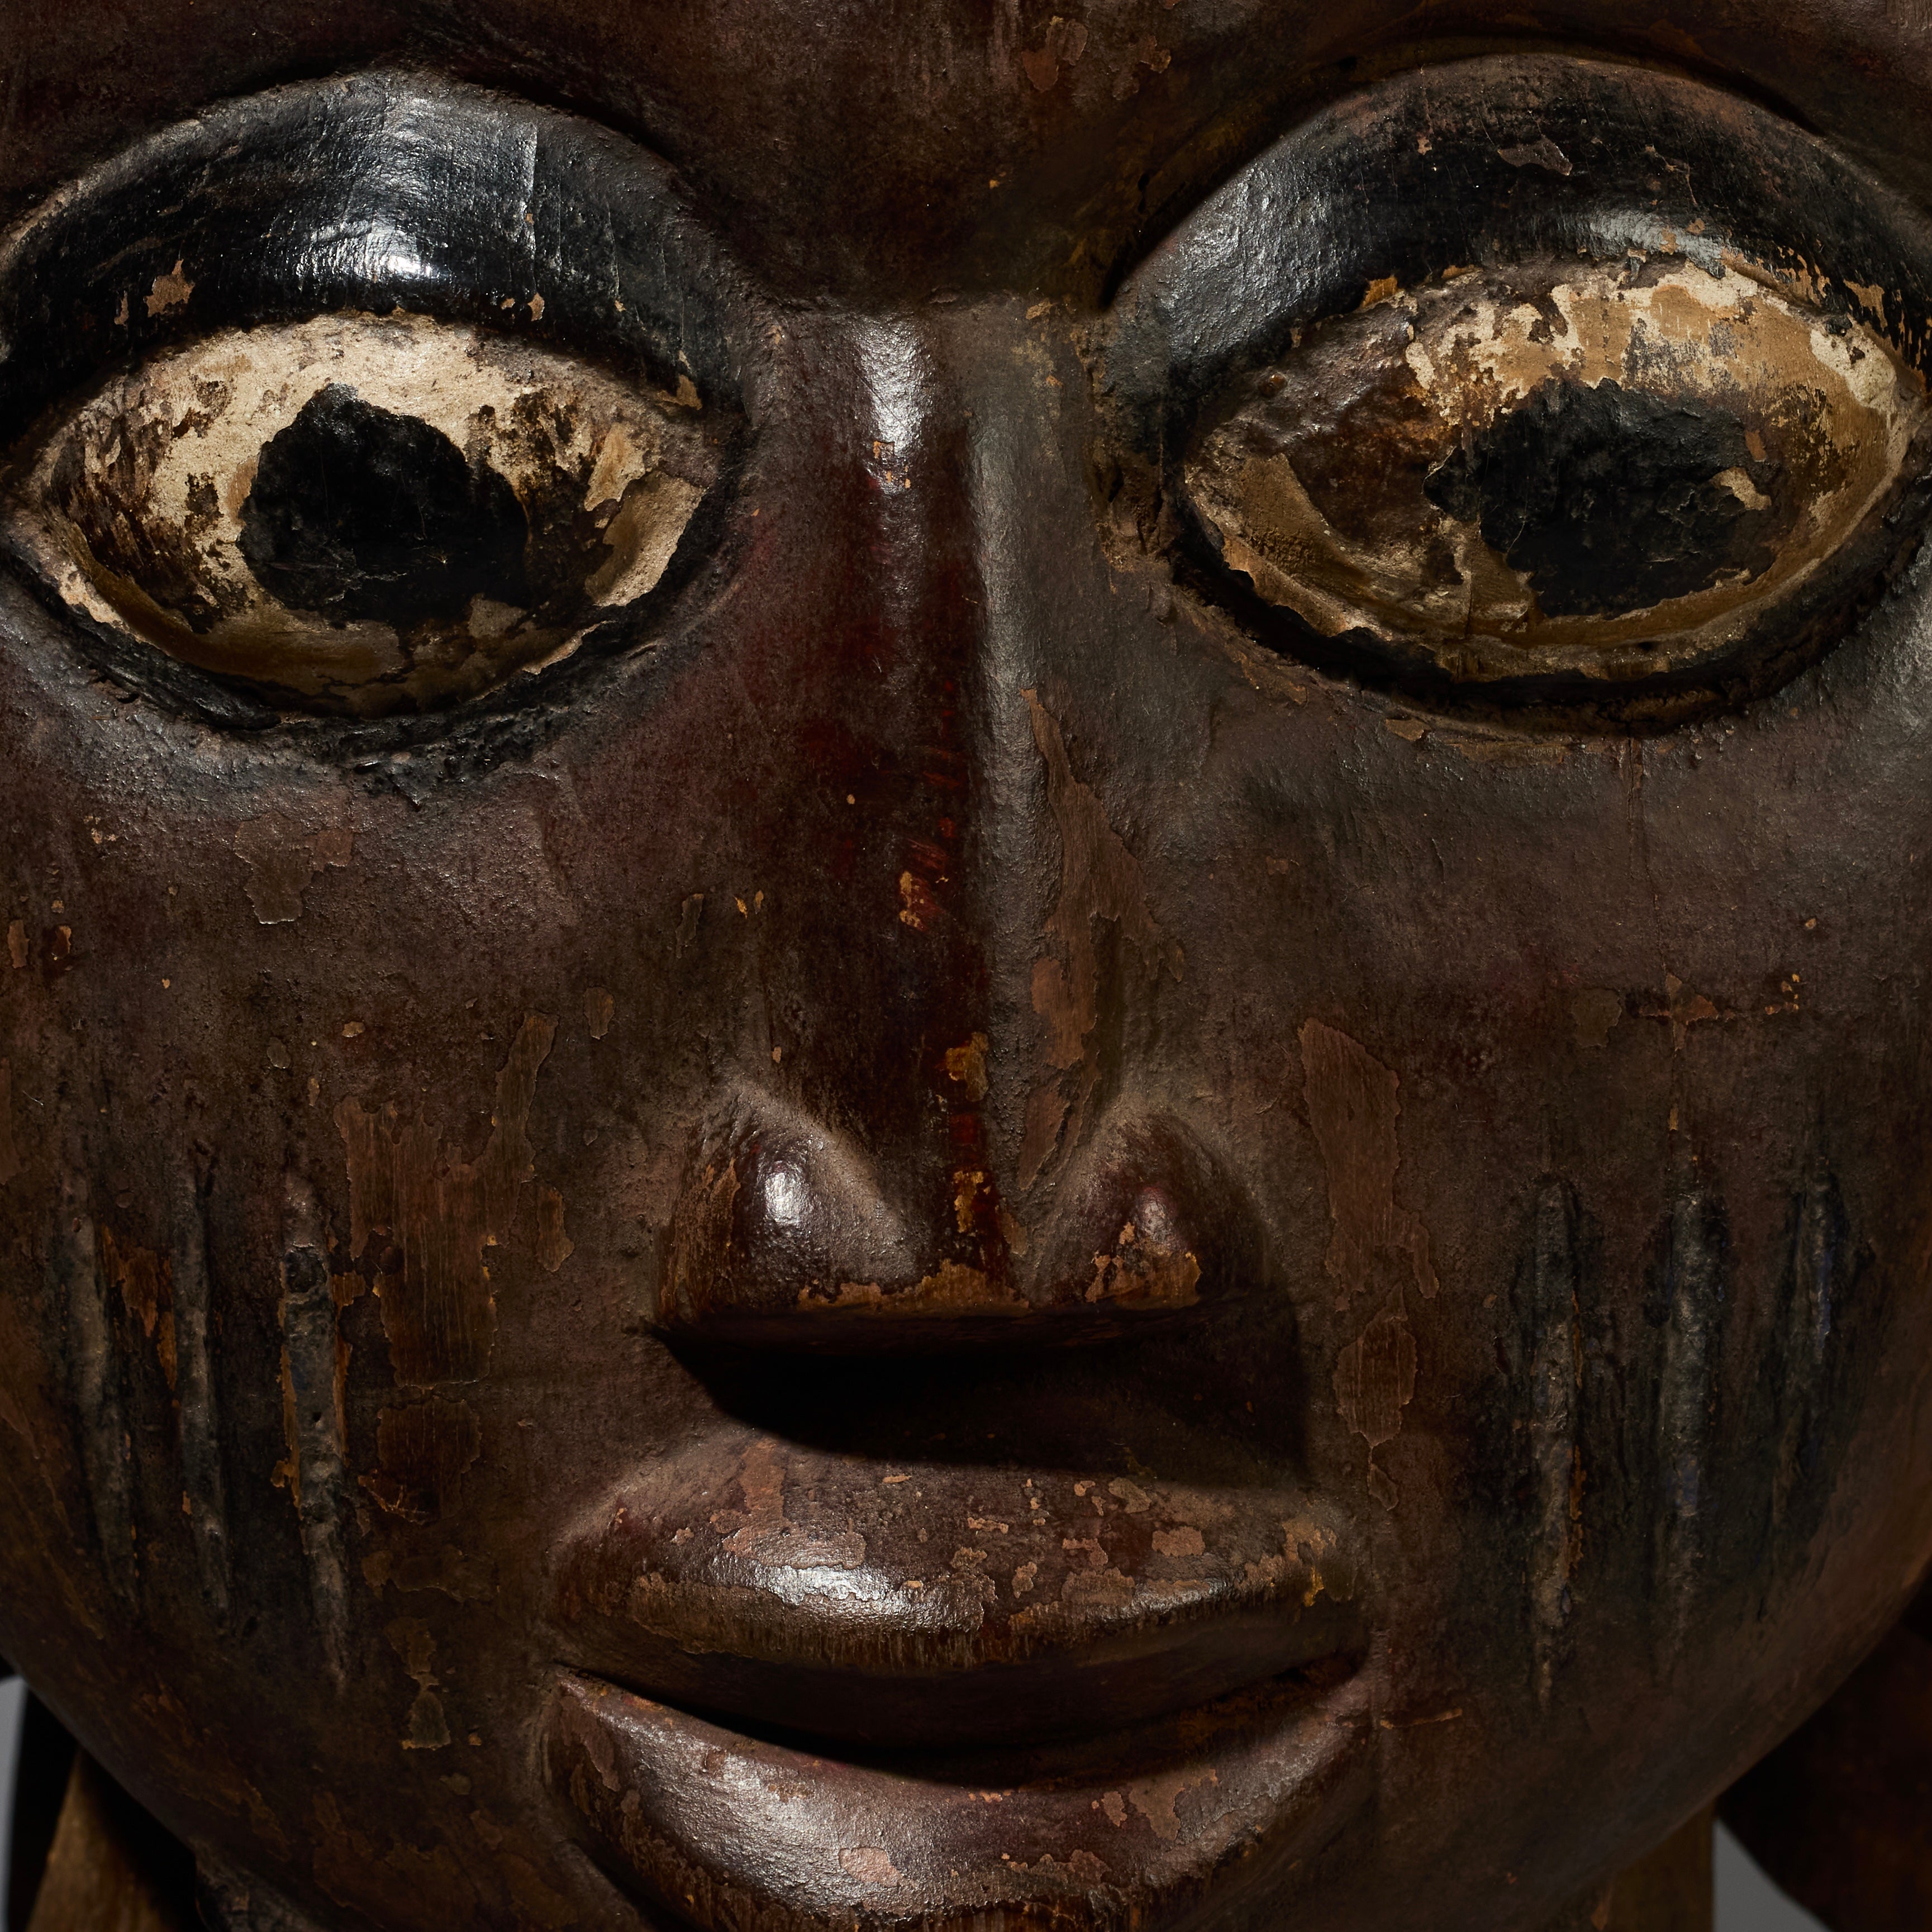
[1103,56,1932,722]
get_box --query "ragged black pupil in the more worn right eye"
[1424,380,1776,616]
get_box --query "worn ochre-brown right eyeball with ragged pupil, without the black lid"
[1182,259,1928,682]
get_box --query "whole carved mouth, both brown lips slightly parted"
[545,1426,1372,1932]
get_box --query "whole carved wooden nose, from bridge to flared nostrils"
[655,303,1236,1349]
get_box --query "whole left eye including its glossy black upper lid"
[0,73,755,726]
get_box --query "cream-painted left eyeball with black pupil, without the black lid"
[4,313,718,717]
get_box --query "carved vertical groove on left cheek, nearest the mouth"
[276,1190,348,1684]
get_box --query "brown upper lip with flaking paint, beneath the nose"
[553,1426,1366,1747]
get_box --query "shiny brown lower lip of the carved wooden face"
[545,1671,1372,1932]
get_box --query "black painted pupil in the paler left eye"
[240,383,529,628]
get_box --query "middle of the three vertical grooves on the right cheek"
[1658,1186,1724,1654]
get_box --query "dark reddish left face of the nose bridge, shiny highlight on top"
[761,315,1003,1273]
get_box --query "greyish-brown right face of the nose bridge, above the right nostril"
[946,301,1178,1229]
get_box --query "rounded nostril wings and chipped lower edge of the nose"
[657,1100,1265,1353]
